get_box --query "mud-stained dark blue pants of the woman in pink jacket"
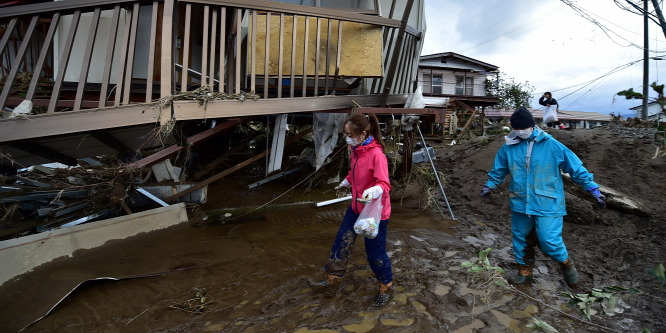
[325,206,393,284]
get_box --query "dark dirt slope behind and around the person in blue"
[426,128,666,332]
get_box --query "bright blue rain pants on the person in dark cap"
[511,211,569,265]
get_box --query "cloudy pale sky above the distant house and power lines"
[422,0,666,117]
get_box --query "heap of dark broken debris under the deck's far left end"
[0,158,150,239]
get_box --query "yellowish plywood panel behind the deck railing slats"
[248,14,383,77]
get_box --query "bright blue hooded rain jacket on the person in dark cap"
[486,127,599,216]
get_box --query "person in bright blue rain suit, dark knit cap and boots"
[481,108,606,287]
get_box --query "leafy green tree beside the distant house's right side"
[486,73,535,109]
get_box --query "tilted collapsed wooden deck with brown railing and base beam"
[0,0,425,167]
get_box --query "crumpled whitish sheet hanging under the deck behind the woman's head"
[312,113,347,170]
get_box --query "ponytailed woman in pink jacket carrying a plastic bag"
[308,113,393,306]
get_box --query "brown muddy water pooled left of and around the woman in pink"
[0,171,455,332]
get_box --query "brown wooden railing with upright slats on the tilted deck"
[0,0,422,113]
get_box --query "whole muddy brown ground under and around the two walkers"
[0,124,666,332]
